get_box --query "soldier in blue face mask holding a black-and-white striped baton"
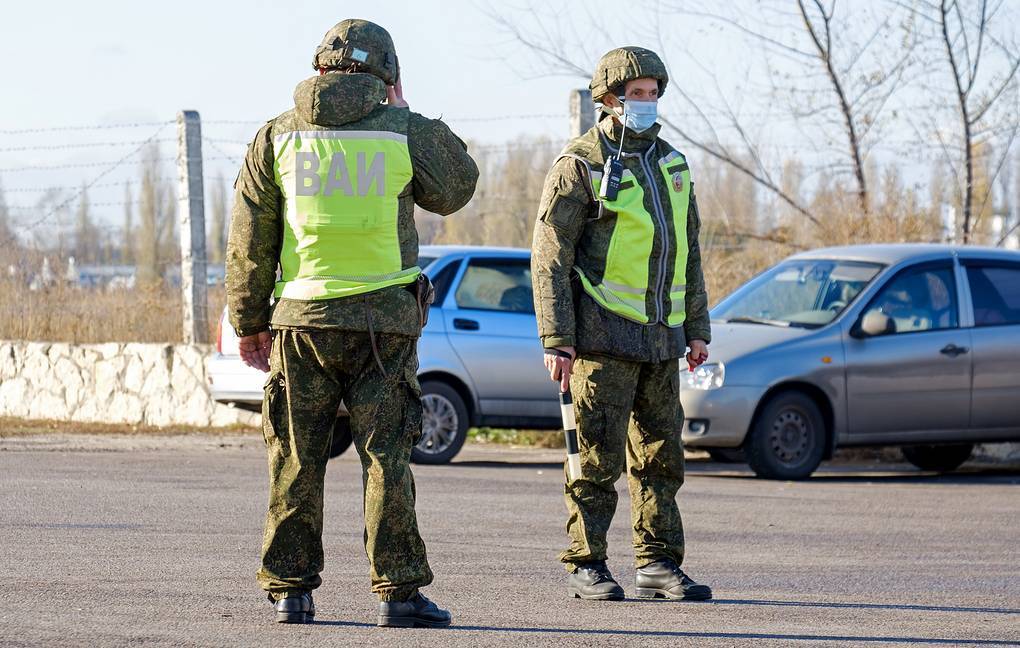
[531,47,712,600]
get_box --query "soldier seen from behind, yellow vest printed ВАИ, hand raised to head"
[226,20,478,627]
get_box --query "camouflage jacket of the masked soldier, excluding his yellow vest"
[531,115,711,362]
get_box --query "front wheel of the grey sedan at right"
[745,392,825,480]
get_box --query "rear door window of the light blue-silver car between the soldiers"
[455,259,534,313]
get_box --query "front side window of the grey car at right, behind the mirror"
[865,266,959,334]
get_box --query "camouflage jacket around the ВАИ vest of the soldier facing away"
[226,72,478,336]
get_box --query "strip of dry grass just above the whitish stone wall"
[0,281,225,344]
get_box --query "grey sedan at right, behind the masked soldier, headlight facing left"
[680,244,1020,479]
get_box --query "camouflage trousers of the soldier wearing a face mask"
[560,354,683,570]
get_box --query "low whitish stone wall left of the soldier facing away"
[0,342,257,427]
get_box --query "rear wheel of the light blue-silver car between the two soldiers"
[411,381,468,463]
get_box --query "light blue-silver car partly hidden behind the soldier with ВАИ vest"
[209,246,560,463]
